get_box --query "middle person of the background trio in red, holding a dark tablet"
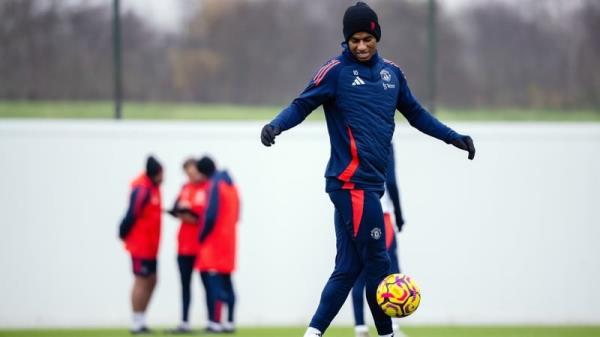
[169,158,207,333]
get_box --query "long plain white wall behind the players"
[0,120,600,326]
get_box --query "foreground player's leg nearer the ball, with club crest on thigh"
[355,191,393,336]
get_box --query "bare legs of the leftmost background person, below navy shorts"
[131,257,156,333]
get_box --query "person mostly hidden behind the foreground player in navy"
[352,145,406,337]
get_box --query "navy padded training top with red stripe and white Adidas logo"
[270,43,461,192]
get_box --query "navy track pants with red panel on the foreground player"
[310,190,392,335]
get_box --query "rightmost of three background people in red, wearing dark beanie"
[195,157,240,333]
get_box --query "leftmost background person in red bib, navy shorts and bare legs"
[119,156,163,334]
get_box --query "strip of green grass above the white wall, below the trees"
[0,101,600,122]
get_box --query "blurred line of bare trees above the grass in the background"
[0,0,600,109]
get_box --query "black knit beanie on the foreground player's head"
[344,1,381,42]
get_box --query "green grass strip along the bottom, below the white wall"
[0,326,600,337]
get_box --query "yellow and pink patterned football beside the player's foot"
[377,274,421,318]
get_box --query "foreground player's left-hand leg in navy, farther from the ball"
[305,191,362,337]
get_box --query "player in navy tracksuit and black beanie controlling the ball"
[261,2,475,337]
